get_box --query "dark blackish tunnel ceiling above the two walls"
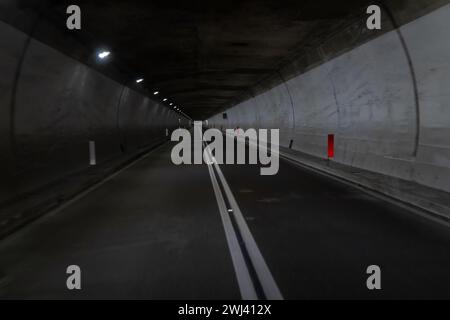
[22,0,372,119]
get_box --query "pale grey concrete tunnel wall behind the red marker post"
[208,5,450,192]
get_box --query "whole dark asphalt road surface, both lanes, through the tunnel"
[0,143,450,299]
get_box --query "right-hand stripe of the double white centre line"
[206,142,283,300]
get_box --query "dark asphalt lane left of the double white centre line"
[0,143,240,299]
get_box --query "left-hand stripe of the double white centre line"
[207,145,258,300]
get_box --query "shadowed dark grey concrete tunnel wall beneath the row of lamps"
[0,22,185,208]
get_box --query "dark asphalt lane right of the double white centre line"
[221,136,450,299]
